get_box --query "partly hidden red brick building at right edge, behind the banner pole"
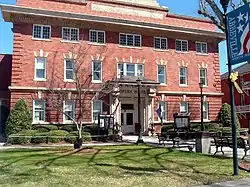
[221,63,250,128]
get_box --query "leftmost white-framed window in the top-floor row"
[33,25,51,39]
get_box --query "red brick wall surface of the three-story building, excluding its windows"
[0,0,223,134]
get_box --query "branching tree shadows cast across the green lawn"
[0,146,236,184]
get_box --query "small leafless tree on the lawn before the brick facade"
[44,44,117,139]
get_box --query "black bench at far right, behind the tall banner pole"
[213,136,250,160]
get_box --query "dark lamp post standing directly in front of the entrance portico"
[136,76,144,144]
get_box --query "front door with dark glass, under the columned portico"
[121,104,135,134]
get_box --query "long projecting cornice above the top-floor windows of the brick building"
[0,4,225,40]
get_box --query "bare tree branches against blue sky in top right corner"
[198,0,249,32]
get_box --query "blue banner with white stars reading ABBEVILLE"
[226,3,250,65]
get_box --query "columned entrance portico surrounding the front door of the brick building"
[111,76,157,134]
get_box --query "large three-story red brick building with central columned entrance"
[1,0,224,133]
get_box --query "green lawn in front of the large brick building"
[0,146,247,187]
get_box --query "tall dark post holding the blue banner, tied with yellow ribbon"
[220,0,239,175]
